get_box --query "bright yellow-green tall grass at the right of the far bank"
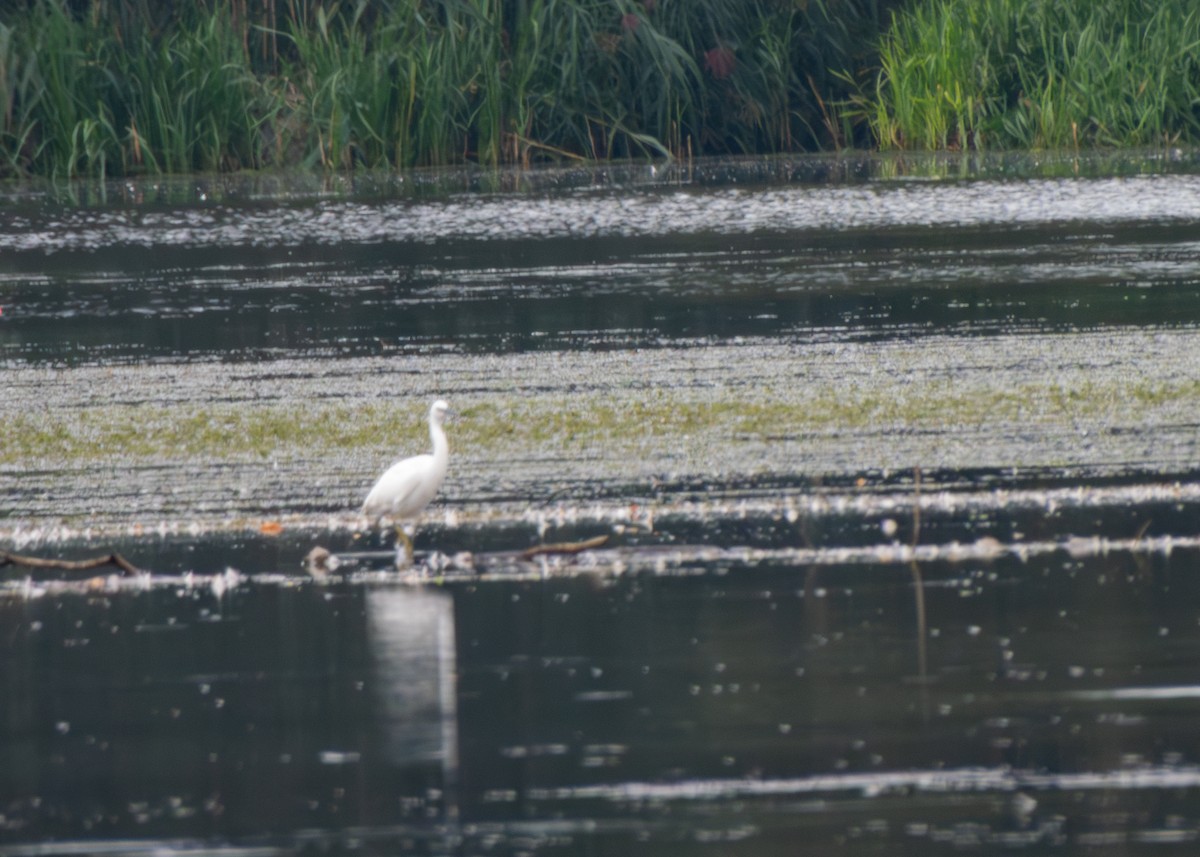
[866,0,1200,149]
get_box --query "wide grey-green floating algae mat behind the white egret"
[0,329,1200,544]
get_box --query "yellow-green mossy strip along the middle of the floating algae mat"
[0,380,1200,467]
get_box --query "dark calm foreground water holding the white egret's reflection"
[7,550,1200,855]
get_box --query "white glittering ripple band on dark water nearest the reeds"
[7,174,1200,252]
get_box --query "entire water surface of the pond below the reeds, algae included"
[7,152,1200,855]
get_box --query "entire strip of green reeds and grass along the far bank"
[0,0,1200,179]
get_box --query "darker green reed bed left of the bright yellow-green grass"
[0,0,895,176]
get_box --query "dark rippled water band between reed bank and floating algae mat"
[7,153,1200,360]
